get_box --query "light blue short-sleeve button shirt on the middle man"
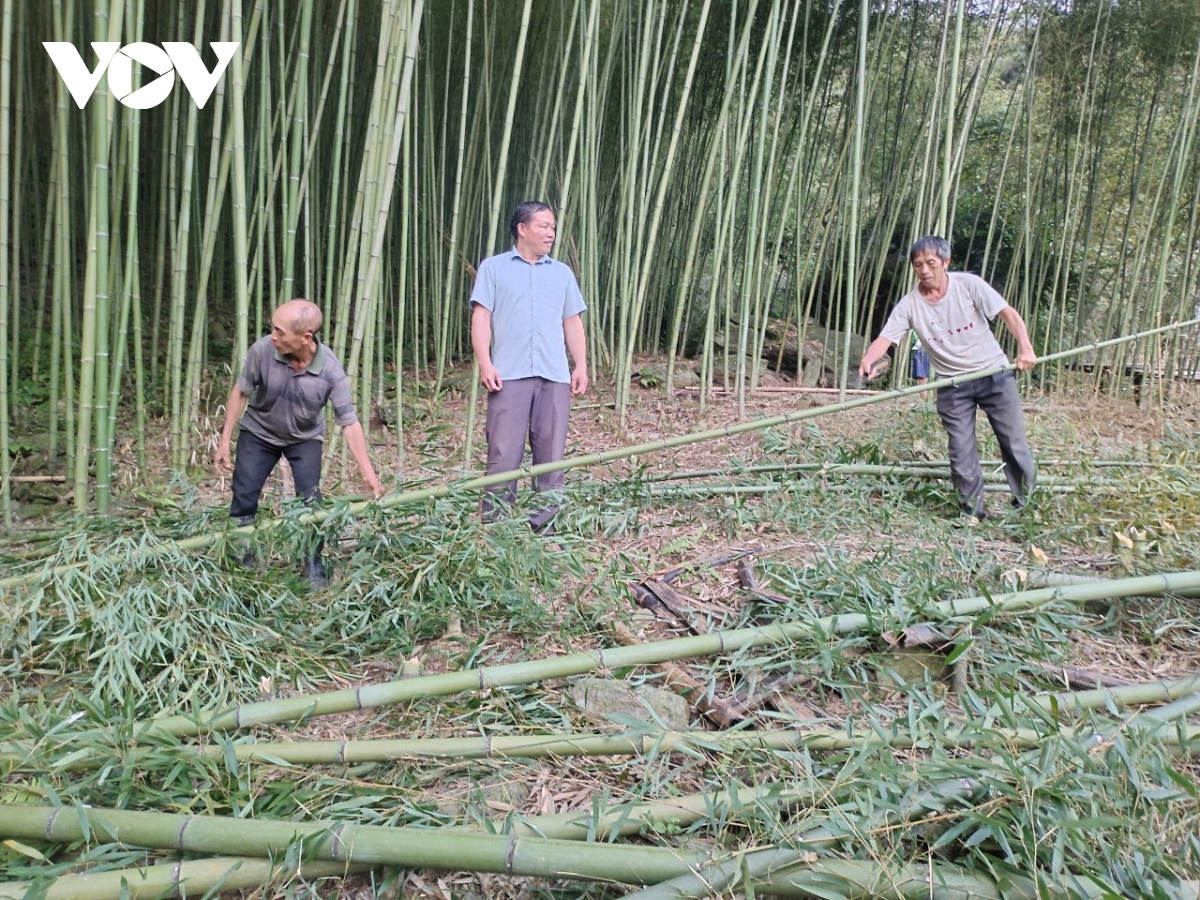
[470,247,587,384]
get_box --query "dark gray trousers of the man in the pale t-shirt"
[937,372,1034,515]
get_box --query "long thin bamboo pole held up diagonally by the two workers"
[0,318,1200,590]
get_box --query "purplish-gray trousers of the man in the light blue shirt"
[482,378,571,532]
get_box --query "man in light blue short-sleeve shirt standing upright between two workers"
[470,200,588,534]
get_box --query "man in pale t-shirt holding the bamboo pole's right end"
[858,235,1038,518]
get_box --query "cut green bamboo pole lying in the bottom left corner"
[0,857,366,900]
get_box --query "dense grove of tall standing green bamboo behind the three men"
[0,0,1200,516]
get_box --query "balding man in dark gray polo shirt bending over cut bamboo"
[216,299,384,588]
